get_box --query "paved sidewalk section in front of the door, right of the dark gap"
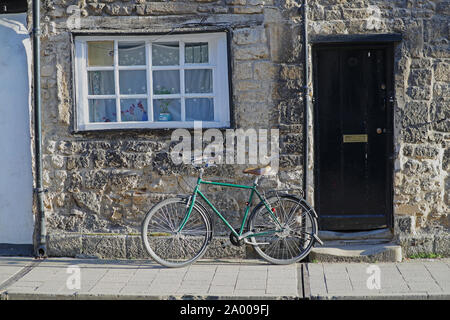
[307,259,450,299]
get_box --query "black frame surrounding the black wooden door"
[311,41,398,231]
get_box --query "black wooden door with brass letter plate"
[314,45,393,231]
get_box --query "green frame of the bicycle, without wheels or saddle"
[177,174,283,239]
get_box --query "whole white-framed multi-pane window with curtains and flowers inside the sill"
[75,33,229,130]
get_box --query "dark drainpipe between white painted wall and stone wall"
[33,0,47,258]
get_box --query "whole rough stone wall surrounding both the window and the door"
[32,0,450,257]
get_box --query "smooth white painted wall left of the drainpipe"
[0,13,34,244]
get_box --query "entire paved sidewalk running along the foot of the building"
[0,257,450,300]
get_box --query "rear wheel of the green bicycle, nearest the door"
[247,195,317,264]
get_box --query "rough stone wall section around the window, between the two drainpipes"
[35,0,303,257]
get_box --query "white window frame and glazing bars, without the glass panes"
[74,32,230,131]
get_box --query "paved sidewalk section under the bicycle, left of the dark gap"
[0,257,303,299]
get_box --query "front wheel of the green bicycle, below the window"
[142,198,212,268]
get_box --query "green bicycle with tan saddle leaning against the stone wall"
[142,160,322,267]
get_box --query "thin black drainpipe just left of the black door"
[303,0,310,198]
